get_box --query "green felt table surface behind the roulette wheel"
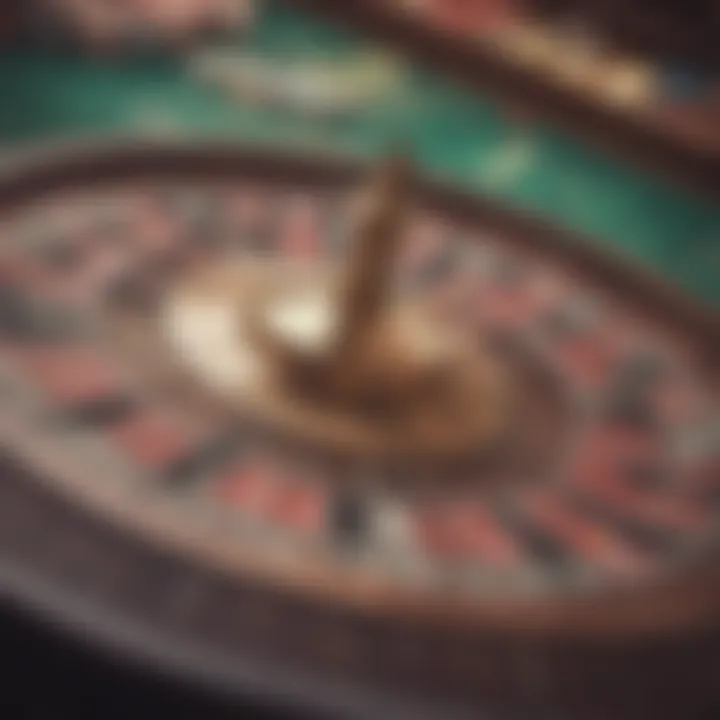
[0,3,720,305]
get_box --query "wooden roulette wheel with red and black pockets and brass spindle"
[0,143,720,718]
